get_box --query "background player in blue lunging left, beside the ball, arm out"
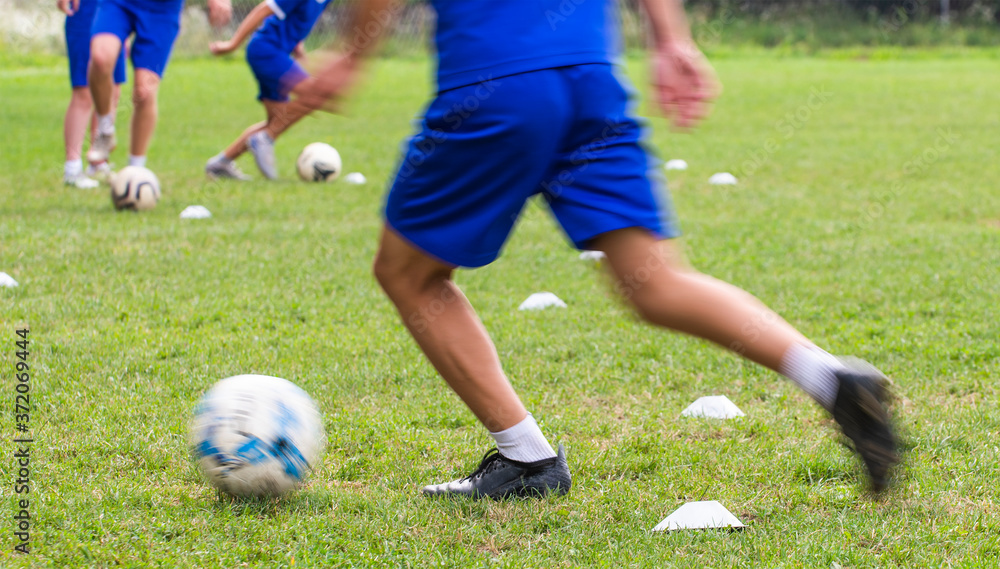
[205,0,330,180]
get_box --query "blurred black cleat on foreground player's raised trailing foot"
[833,360,899,492]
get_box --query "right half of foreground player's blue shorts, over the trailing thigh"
[541,65,680,249]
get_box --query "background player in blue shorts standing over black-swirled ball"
[87,0,232,166]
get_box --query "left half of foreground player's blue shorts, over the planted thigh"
[385,70,568,267]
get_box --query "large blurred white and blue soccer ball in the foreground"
[189,375,326,498]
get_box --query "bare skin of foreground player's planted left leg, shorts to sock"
[374,223,528,432]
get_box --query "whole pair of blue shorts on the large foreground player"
[385,64,680,267]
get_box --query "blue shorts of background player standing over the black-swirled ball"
[91,0,184,77]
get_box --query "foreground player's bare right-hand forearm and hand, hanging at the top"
[642,0,719,128]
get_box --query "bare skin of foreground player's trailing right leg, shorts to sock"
[593,228,812,371]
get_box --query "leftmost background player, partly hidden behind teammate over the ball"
[56,0,125,190]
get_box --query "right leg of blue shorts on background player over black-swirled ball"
[128,0,184,77]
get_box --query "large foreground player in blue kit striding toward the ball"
[300,0,899,498]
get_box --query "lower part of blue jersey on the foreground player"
[431,0,620,91]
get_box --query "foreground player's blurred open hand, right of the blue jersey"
[653,42,721,129]
